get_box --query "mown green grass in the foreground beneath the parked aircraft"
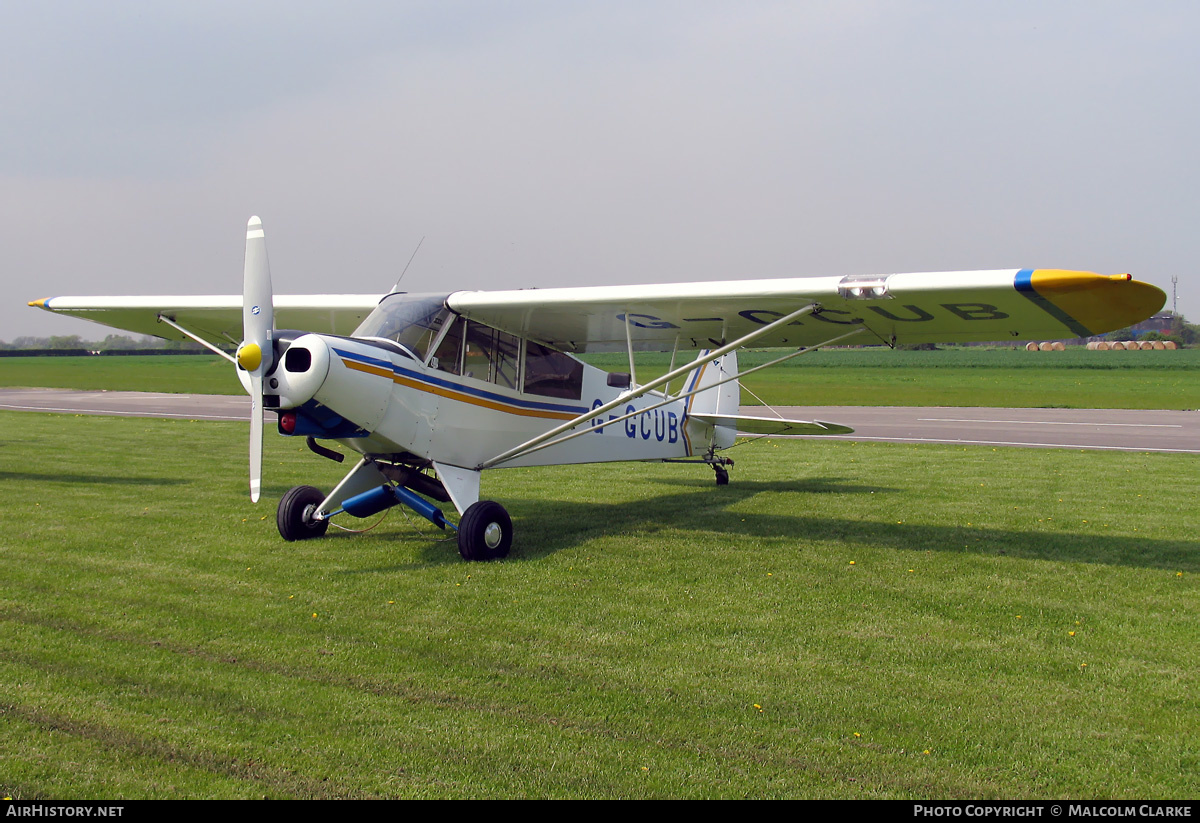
[0,413,1200,799]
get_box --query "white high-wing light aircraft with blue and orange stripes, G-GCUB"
[30,217,1166,560]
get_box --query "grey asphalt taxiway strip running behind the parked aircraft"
[0,389,1200,455]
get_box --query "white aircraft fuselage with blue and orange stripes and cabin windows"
[266,295,714,468]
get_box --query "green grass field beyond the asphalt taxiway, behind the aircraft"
[0,348,1200,409]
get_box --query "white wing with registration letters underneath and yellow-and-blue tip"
[446,269,1166,352]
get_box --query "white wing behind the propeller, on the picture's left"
[29,294,383,343]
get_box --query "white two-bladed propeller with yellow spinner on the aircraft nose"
[238,217,275,503]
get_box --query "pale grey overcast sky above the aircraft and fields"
[0,0,1200,341]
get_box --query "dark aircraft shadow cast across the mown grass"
[338,477,1200,572]
